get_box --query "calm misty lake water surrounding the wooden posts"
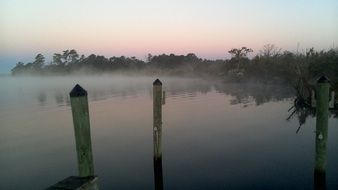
[0,76,338,190]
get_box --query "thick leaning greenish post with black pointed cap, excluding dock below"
[70,84,94,177]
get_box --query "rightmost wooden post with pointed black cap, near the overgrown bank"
[314,76,330,189]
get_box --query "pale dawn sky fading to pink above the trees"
[0,0,338,74]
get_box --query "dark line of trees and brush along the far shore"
[11,44,338,82]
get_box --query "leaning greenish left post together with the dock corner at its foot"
[46,84,99,190]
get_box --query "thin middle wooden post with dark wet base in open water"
[153,79,163,190]
